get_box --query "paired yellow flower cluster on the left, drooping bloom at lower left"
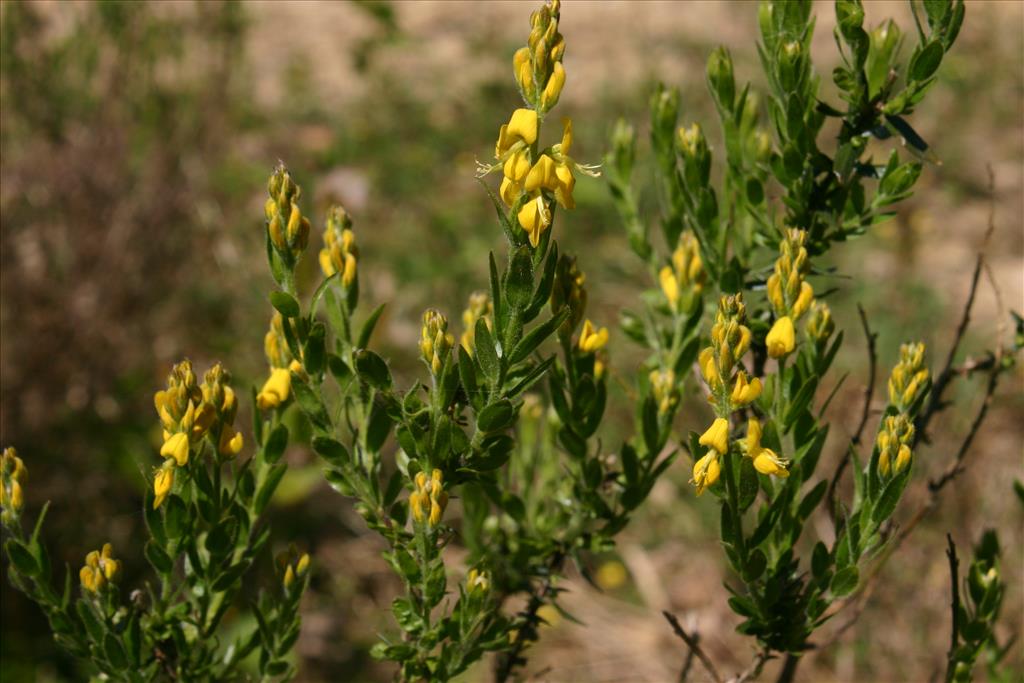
[153,360,243,508]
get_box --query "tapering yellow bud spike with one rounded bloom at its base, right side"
[765,228,814,358]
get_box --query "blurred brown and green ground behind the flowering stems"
[0,0,1024,682]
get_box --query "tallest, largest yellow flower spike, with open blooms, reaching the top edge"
[480,0,597,247]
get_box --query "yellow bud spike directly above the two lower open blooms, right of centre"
[697,294,762,416]
